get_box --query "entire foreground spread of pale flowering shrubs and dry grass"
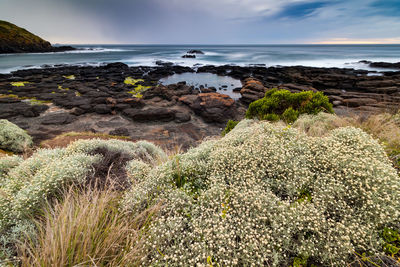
[0,106,400,266]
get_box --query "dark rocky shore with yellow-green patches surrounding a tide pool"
[0,63,400,149]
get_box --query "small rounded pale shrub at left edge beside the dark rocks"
[0,120,33,153]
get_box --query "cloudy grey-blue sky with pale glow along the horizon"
[0,0,400,44]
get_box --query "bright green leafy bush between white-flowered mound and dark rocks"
[246,89,333,123]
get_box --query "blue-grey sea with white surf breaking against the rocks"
[0,45,400,73]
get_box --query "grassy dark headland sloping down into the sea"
[0,20,75,54]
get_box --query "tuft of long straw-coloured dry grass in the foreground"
[19,184,160,266]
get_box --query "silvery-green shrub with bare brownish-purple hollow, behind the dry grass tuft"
[0,140,165,263]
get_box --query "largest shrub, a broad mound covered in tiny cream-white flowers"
[122,120,400,266]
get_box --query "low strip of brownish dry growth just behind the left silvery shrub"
[40,132,131,148]
